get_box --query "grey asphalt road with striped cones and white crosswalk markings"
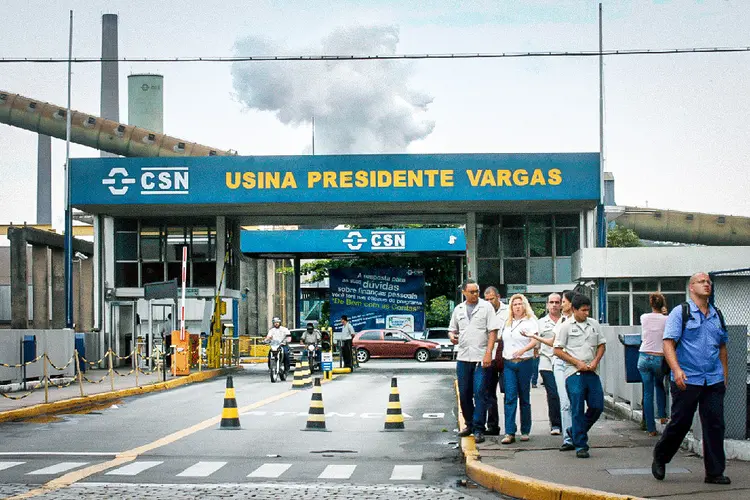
[0,360,512,500]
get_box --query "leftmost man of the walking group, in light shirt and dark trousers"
[448,279,501,443]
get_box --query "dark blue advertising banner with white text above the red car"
[329,268,424,333]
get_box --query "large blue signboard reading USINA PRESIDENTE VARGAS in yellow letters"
[71,153,599,207]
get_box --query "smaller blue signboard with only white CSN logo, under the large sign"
[240,228,466,254]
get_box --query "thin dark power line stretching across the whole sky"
[0,47,750,64]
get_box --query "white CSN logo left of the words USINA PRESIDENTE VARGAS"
[102,167,190,196]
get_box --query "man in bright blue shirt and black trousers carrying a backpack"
[651,273,732,484]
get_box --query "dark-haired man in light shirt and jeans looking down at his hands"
[554,293,607,458]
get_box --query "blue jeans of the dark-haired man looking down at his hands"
[565,372,604,450]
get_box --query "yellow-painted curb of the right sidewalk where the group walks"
[454,381,642,500]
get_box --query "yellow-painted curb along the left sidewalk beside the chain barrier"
[0,368,237,422]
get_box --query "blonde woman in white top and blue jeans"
[500,293,539,444]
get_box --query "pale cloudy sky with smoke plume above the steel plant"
[0,0,750,227]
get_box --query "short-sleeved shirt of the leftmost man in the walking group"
[448,299,502,363]
